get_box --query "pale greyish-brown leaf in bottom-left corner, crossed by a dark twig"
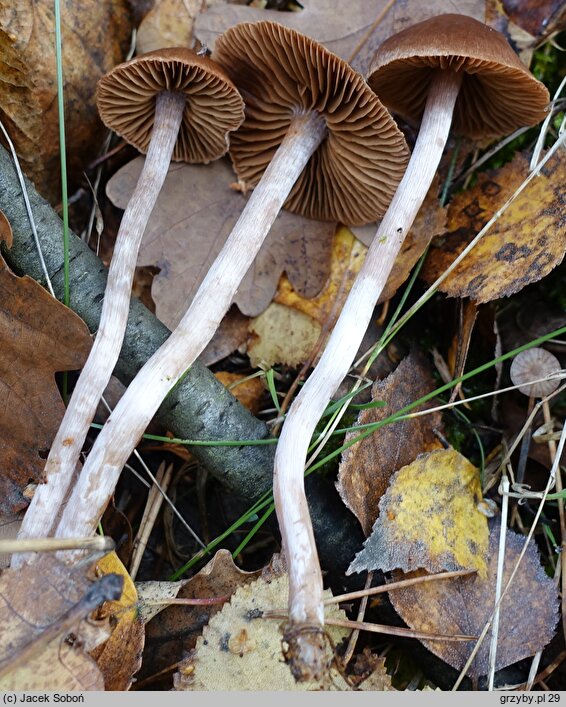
[0,556,117,691]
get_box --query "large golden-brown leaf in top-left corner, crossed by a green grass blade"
[0,0,131,203]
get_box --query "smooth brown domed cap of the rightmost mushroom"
[368,15,550,138]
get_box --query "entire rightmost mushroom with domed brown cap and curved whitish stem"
[274,9,549,676]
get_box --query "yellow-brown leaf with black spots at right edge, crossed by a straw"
[422,151,566,304]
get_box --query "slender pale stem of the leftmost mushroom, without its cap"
[12,91,186,567]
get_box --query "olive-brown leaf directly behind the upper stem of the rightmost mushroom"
[352,179,447,303]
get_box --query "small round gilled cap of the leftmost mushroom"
[96,47,244,163]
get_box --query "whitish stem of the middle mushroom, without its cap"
[56,113,326,548]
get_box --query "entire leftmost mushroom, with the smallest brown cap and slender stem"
[13,48,244,566]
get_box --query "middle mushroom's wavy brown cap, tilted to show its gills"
[213,21,409,225]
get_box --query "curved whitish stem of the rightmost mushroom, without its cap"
[274,71,461,677]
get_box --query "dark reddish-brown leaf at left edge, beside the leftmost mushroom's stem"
[0,253,91,515]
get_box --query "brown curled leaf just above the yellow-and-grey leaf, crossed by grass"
[338,353,442,535]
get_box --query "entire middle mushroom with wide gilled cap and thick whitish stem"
[45,22,408,676]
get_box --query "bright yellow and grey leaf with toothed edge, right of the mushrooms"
[347,449,489,577]
